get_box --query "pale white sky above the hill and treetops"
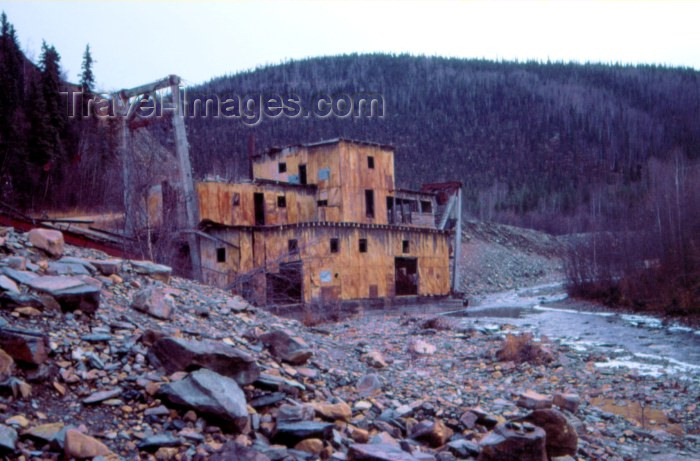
[0,0,700,90]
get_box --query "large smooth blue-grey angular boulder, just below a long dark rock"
[159,368,249,432]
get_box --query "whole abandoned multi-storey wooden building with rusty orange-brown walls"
[196,139,461,304]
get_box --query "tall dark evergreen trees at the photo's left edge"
[0,13,121,212]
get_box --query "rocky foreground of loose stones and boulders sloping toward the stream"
[0,229,700,461]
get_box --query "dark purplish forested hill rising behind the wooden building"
[188,55,700,232]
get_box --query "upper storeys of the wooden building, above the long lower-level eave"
[197,139,437,228]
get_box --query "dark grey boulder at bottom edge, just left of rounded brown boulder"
[479,422,547,461]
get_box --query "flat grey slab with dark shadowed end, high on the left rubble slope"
[27,276,102,314]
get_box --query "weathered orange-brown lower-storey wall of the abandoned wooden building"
[202,226,451,303]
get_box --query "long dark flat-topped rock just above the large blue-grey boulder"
[149,337,260,386]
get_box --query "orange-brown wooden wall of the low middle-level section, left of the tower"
[197,182,316,226]
